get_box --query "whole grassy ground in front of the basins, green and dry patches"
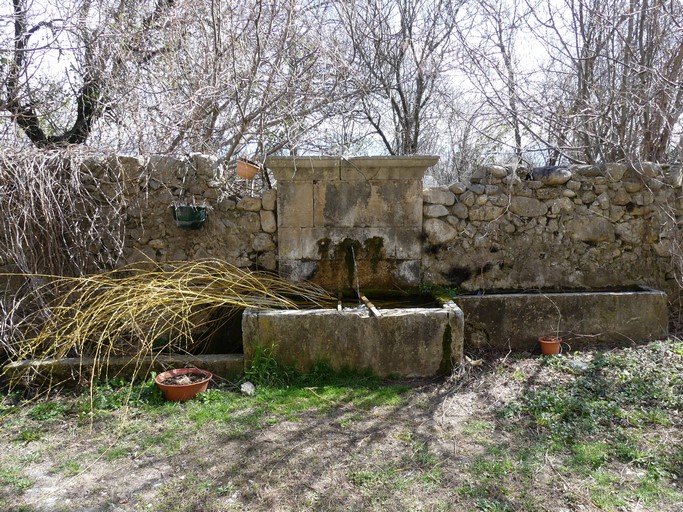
[0,340,683,512]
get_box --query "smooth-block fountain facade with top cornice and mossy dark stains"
[266,156,438,292]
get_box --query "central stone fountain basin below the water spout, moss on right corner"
[242,302,464,377]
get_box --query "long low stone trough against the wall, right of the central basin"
[454,287,668,352]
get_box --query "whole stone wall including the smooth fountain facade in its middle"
[12,154,683,302]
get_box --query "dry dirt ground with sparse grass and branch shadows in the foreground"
[0,344,683,512]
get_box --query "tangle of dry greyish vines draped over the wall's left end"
[0,147,125,358]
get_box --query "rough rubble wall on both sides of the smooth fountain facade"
[44,154,683,302]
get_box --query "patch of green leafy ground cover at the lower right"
[492,340,683,510]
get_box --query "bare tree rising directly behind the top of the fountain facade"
[335,0,462,154]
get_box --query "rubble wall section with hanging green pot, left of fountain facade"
[103,153,277,270]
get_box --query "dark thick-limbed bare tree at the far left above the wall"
[0,0,179,147]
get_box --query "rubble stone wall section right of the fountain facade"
[422,164,683,293]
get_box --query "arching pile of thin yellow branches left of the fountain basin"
[2,259,333,384]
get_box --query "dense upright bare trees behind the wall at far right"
[530,0,683,162]
